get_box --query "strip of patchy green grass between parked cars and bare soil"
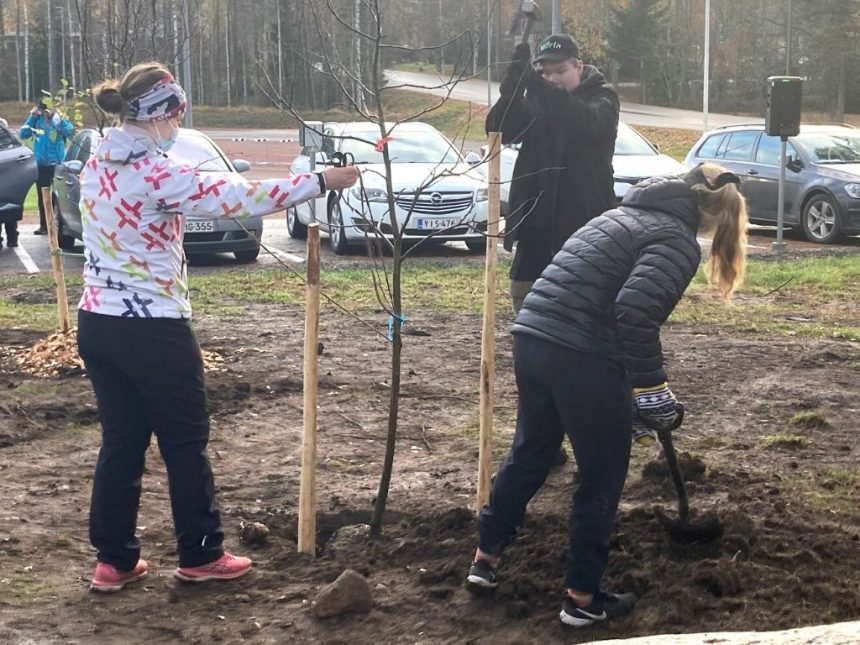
[0,234,860,341]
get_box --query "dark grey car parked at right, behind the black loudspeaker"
[684,125,860,244]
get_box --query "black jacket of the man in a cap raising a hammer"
[486,65,619,270]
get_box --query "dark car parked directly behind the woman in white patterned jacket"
[53,128,263,262]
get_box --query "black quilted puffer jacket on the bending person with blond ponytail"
[513,177,701,387]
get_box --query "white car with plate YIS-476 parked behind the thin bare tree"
[287,122,487,254]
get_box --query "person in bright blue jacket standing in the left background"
[19,101,75,235]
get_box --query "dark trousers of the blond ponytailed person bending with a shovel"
[479,334,632,593]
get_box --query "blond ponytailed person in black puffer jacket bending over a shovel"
[467,164,747,627]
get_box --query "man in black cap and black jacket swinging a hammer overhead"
[486,35,619,312]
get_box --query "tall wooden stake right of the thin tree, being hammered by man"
[475,132,502,512]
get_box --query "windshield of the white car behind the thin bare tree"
[341,130,460,164]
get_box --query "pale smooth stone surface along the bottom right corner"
[592,622,860,645]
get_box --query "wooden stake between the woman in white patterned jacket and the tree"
[299,224,320,556]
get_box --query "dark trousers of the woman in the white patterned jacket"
[78,311,224,571]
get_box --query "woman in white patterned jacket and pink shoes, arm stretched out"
[78,63,358,592]
